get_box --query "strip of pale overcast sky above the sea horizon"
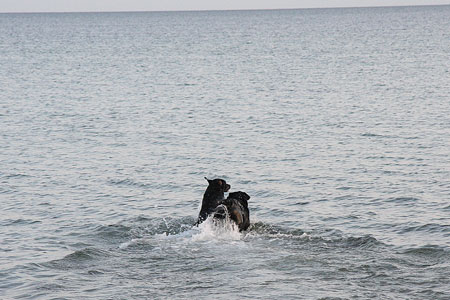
[0,0,450,12]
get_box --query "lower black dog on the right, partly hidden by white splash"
[214,191,250,231]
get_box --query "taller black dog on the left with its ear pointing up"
[196,177,231,225]
